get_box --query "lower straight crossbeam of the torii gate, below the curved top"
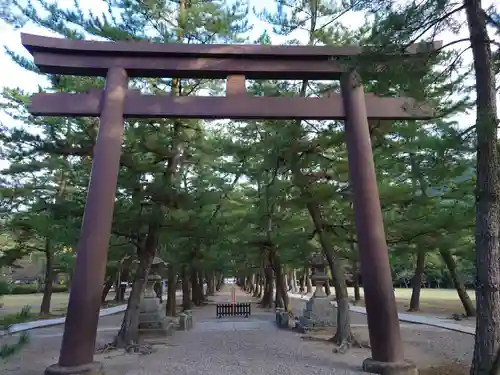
[29,90,434,120]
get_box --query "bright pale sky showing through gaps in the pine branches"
[0,0,495,150]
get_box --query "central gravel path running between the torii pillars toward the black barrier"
[95,289,361,375]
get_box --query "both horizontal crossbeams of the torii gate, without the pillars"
[21,34,440,120]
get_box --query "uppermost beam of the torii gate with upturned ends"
[21,33,440,80]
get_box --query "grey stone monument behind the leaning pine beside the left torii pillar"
[138,275,175,335]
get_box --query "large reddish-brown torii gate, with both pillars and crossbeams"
[22,34,439,374]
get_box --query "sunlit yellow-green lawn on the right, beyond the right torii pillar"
[348,288,476,316]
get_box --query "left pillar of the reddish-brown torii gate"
[45,67,128,375]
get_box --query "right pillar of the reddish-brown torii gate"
[341,70,418,375]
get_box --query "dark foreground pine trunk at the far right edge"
[464,0,500,375]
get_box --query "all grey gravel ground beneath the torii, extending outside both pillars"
[0,290,473,375]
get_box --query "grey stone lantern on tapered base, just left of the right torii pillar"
[295,254,337,331]
